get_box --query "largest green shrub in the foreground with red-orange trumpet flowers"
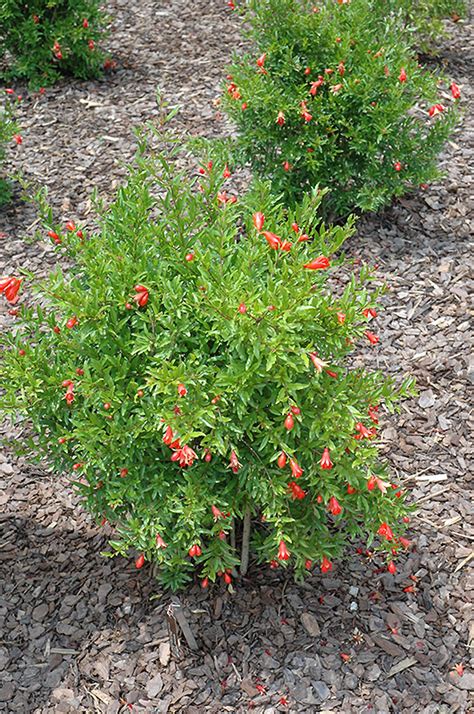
[0,145,411,588]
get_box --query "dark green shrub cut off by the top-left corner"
[0,0,105,87]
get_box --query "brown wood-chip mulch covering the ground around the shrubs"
[0,0,474,714]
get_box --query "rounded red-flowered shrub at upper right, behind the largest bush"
[223,0,459,216]
